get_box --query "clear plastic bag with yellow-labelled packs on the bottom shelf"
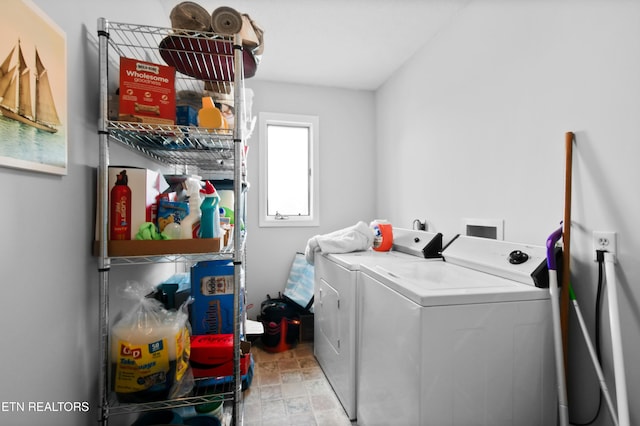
[111,282,194,403]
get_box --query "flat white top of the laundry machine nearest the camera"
[361,262,549,306]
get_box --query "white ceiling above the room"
[158,0,471,90]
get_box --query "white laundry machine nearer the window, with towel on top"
[313,228,442,420]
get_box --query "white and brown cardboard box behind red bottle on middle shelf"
[108,166,168,239]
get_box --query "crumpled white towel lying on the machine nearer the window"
[304,221,373,265]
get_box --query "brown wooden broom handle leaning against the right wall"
[560,132,575,375]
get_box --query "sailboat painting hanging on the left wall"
[0,0,68,175]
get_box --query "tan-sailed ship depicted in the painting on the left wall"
[0,40,61,133]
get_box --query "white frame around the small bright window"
[258,112,320,228]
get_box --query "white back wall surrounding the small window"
[246,80,376,318]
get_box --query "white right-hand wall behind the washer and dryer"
[376,0,640,425]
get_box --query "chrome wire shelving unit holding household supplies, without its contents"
[100,21,249,423]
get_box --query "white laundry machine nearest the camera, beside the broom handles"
[357,237,557,426]
